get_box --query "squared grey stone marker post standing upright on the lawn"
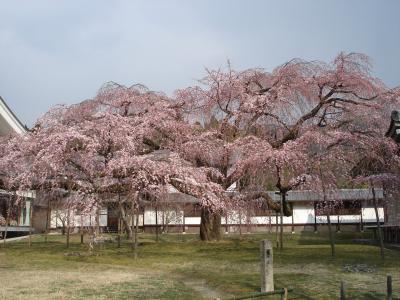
[260,240,274,293]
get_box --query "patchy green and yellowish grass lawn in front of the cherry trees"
[0,233,400,300]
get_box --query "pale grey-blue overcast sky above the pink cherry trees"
[0,0,400,126]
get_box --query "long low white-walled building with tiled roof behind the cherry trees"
[51,189,385,233]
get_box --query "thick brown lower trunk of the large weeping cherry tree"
[200,207,221,241]
